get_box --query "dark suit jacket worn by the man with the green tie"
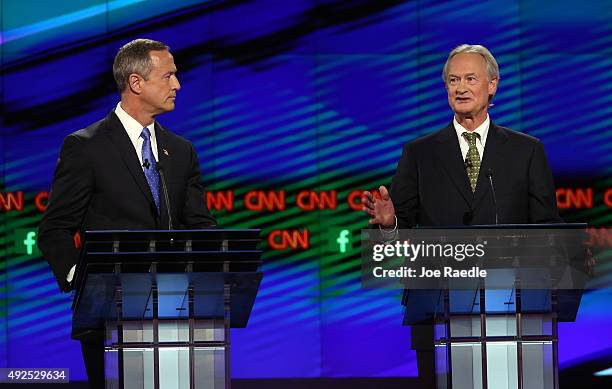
[390,122,561,228]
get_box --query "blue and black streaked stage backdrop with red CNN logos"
[0,0,612,379]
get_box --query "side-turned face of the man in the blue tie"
[140,50,181,115]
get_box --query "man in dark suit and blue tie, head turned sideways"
[38,39,215,388]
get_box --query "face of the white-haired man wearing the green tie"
[446,53,497,117]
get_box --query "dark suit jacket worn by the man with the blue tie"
[38,112,215,291]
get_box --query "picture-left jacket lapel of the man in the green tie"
[436,123,474,205]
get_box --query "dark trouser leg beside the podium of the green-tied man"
[411,324,436,389]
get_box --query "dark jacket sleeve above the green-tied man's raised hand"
[389,145,419,228]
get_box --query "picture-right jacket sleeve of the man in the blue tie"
[181,144,217,228]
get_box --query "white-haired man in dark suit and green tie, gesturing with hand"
[362,45,561,388]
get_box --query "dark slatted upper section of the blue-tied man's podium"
[73,229,263,331]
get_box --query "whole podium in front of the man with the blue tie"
[73,229,262,389]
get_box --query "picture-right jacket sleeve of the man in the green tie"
[529,141,563,223]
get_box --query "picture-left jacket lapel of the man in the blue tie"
[106,112,155,207]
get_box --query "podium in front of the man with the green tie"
[402,224,588,389]
